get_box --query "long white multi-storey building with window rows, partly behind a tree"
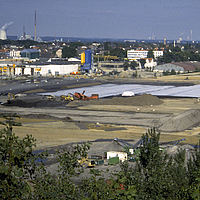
[127,49,163,60]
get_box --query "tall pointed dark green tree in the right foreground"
[122,128,189,199]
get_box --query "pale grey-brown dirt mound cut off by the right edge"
[159,109,200,132]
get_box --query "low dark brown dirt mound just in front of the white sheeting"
[97,94,163,106]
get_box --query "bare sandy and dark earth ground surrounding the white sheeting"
[0,73,200,176]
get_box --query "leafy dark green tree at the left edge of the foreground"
[0,114,44,199]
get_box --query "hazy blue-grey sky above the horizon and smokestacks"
[0,0,200,40]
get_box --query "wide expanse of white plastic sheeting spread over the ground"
[40,84,200,98]
